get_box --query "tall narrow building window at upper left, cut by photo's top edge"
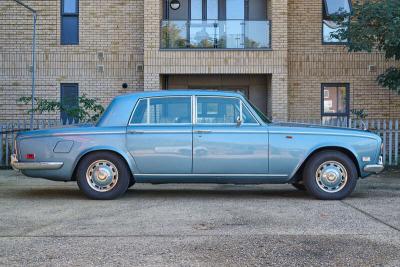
[61,0,79,45]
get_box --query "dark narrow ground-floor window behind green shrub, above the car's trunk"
[60,83,79,124]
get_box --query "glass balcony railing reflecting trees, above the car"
[161,20,271,49]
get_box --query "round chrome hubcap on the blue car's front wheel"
[315,161,347,193]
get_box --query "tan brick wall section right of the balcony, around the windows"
[288,0,400,119]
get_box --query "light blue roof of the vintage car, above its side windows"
[114,89,243,98]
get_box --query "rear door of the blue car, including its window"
[126,96,192,174]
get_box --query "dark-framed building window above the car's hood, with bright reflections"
[321,83,350,122]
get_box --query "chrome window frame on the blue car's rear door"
[128,95,193,126]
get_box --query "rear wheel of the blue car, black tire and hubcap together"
[76,151,131,200]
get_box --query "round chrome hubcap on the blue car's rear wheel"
[86,160,118,192]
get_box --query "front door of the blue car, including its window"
[193,96,268,176]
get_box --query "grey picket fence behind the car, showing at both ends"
[0,119,399,167]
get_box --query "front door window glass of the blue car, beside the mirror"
[197,97,257,124]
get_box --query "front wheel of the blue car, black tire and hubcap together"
[303,150,358,200]
